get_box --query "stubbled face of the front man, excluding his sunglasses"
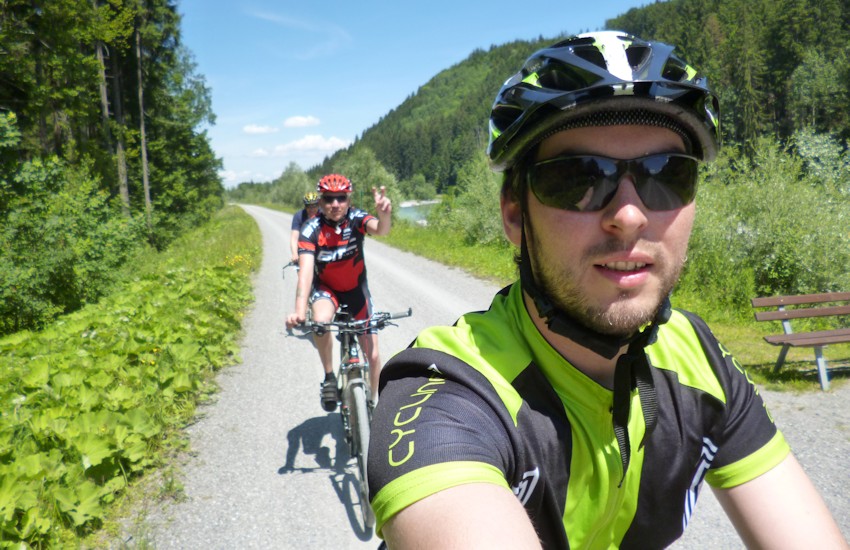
[506,126,695,335]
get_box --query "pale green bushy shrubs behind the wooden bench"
[680,138,850,309]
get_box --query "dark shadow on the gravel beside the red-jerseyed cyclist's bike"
[277,412,372,541]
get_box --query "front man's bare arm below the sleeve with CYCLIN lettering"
[383,483,540,550]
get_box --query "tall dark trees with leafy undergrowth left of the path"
[0,0,223,335]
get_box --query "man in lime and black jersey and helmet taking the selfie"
[369,32,847,549]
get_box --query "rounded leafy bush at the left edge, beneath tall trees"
[0,157,143,334]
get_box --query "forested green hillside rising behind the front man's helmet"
[311,0,850,191]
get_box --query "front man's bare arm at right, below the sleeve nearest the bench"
[714,454,850,549]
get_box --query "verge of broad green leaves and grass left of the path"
[0,208,261,547]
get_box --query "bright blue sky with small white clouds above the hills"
[178,0,648,187]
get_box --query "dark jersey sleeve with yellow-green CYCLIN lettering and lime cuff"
[369,349,512,534]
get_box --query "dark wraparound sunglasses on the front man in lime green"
[527,153,699,212]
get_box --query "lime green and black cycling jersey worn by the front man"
[369,285,789,548]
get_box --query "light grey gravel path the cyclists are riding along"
[119,206,850,550]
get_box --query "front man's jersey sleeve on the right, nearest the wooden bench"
[688,314,790,488]
